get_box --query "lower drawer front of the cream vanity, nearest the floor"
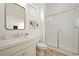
[14,45,36,56]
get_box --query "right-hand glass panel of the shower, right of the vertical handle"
[52,10,79,53]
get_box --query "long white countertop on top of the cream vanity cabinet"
[0,36,39,50]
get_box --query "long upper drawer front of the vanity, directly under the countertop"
[0,41,35,56]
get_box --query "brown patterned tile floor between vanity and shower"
[37,48,65,56]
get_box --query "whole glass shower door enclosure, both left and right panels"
[46,9,79,54]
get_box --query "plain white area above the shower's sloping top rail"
[45,3,79,16]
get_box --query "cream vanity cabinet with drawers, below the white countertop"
[0,39,38,56]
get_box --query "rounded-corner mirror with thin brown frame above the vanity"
[5,3,26,30]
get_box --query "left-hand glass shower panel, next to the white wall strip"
[45,17,58,47]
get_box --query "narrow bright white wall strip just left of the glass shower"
[34,3,45,42]
